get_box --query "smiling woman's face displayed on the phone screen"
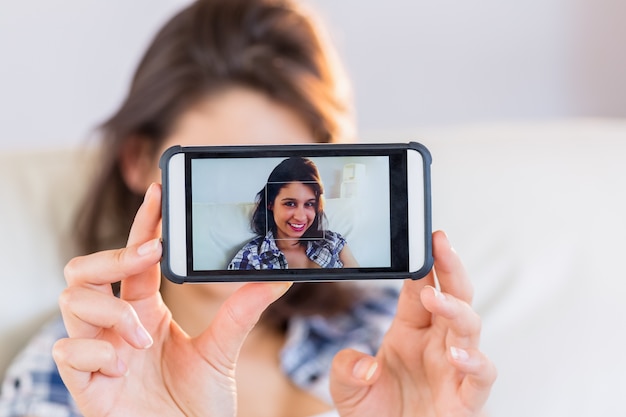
[269,182,317,240]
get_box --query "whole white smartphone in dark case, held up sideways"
[160,142,433,283]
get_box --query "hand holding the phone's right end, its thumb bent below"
[330,232,497,417]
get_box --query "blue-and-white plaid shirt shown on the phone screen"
[228,230,346,269]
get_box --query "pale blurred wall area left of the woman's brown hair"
[0,0,185,147]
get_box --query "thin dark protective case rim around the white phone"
[159,142,434,284]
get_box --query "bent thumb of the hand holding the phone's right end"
[330,349,380,410]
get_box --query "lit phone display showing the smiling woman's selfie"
[188,156,392,272]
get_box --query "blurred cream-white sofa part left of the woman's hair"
[0,145,90,375]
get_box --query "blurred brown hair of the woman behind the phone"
[77,0,353,325]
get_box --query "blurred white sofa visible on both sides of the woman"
[0,119,626,417]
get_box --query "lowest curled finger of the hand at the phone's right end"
[448,346,498,410]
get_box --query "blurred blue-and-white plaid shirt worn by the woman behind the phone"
[0,285,398,417]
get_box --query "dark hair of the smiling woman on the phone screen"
[251,157,326,243]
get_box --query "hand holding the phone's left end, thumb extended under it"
[53,184,289,417]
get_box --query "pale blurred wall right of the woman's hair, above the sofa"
[314,0,626,130]
